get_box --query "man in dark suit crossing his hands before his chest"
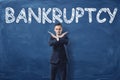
[48,23,68,80]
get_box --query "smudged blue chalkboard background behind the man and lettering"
[0,0,120,80]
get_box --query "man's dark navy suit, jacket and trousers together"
[49,36,68,80]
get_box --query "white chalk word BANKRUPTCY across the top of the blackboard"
[5,7,118,24]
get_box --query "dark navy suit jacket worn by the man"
[49,36,68,64]
